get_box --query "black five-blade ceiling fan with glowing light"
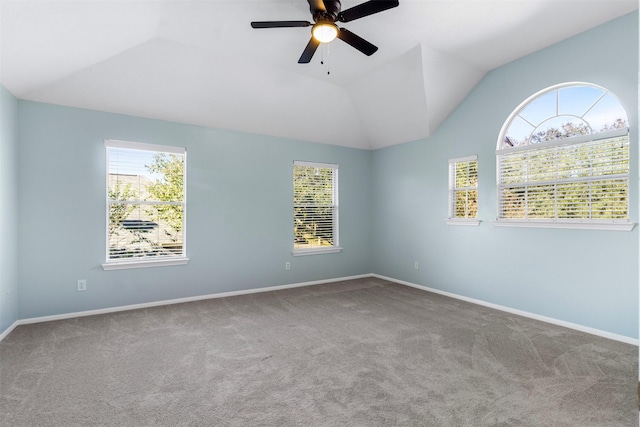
[251,0,399,64]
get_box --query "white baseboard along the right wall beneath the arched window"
[371,274,640,346]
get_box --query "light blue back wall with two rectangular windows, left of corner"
[19,101,372,318]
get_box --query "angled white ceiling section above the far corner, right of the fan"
[350,44,485,149]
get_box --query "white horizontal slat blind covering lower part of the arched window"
[497,134,629,221]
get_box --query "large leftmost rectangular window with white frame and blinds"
[103,140,188,270]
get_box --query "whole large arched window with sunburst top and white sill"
[496,83,633,230]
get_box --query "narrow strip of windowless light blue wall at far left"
[0,85,18,334]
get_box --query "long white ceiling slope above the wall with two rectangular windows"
[24,38,366,148]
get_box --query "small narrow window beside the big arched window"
[447,156,480,225]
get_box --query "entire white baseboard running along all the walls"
[0,273,640,346]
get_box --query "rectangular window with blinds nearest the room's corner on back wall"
[293,161,341,255]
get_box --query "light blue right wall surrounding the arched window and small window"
[372,13,639,338]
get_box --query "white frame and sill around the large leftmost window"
[102,139,189,270]
